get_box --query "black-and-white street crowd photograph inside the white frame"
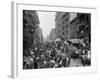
[22,10,91,69]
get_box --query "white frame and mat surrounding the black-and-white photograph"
[11,2,97,78]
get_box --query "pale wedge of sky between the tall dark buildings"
[37,11,56,39]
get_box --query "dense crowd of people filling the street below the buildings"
[23,41,91,69]
